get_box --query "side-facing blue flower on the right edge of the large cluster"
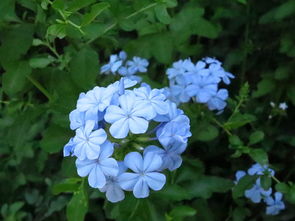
[156,115,192,147]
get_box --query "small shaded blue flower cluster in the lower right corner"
[235,163,285,215]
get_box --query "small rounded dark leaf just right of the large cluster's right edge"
[193,122,219,142]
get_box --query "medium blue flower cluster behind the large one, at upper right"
[166,57,234,111]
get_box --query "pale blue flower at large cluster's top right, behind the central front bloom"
[134,87,168,120]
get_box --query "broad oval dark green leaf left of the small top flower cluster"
[70,47,99,89]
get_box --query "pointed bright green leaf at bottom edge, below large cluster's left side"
[67,183,88,221]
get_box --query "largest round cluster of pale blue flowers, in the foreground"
[64,77,191,202]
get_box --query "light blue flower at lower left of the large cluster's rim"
[76,141,119,188]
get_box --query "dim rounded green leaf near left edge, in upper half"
[2,61,32,96]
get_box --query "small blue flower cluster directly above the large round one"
[100,51,149,82]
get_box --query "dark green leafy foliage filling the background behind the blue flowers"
[0,0,295,221]
